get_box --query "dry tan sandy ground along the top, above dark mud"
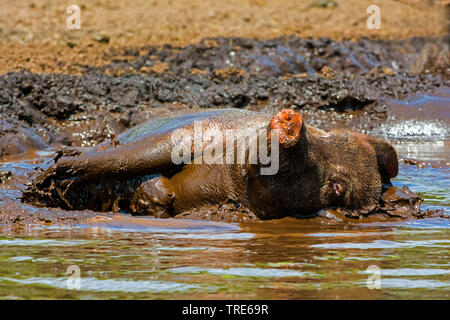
[0,0,450,74]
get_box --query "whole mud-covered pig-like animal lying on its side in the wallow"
[23,109,398,219]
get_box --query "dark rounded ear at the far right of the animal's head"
[364,135,398,178]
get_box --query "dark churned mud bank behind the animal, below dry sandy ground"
[0,36,449,156]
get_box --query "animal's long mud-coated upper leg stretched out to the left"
[22,136,178,207]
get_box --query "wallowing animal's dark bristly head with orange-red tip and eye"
[250,109,398,217]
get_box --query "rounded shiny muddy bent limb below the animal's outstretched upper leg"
[130,177,175,218]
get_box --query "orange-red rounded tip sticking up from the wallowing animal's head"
[269,109,303,148]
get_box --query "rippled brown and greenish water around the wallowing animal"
[0,136,450,299]
